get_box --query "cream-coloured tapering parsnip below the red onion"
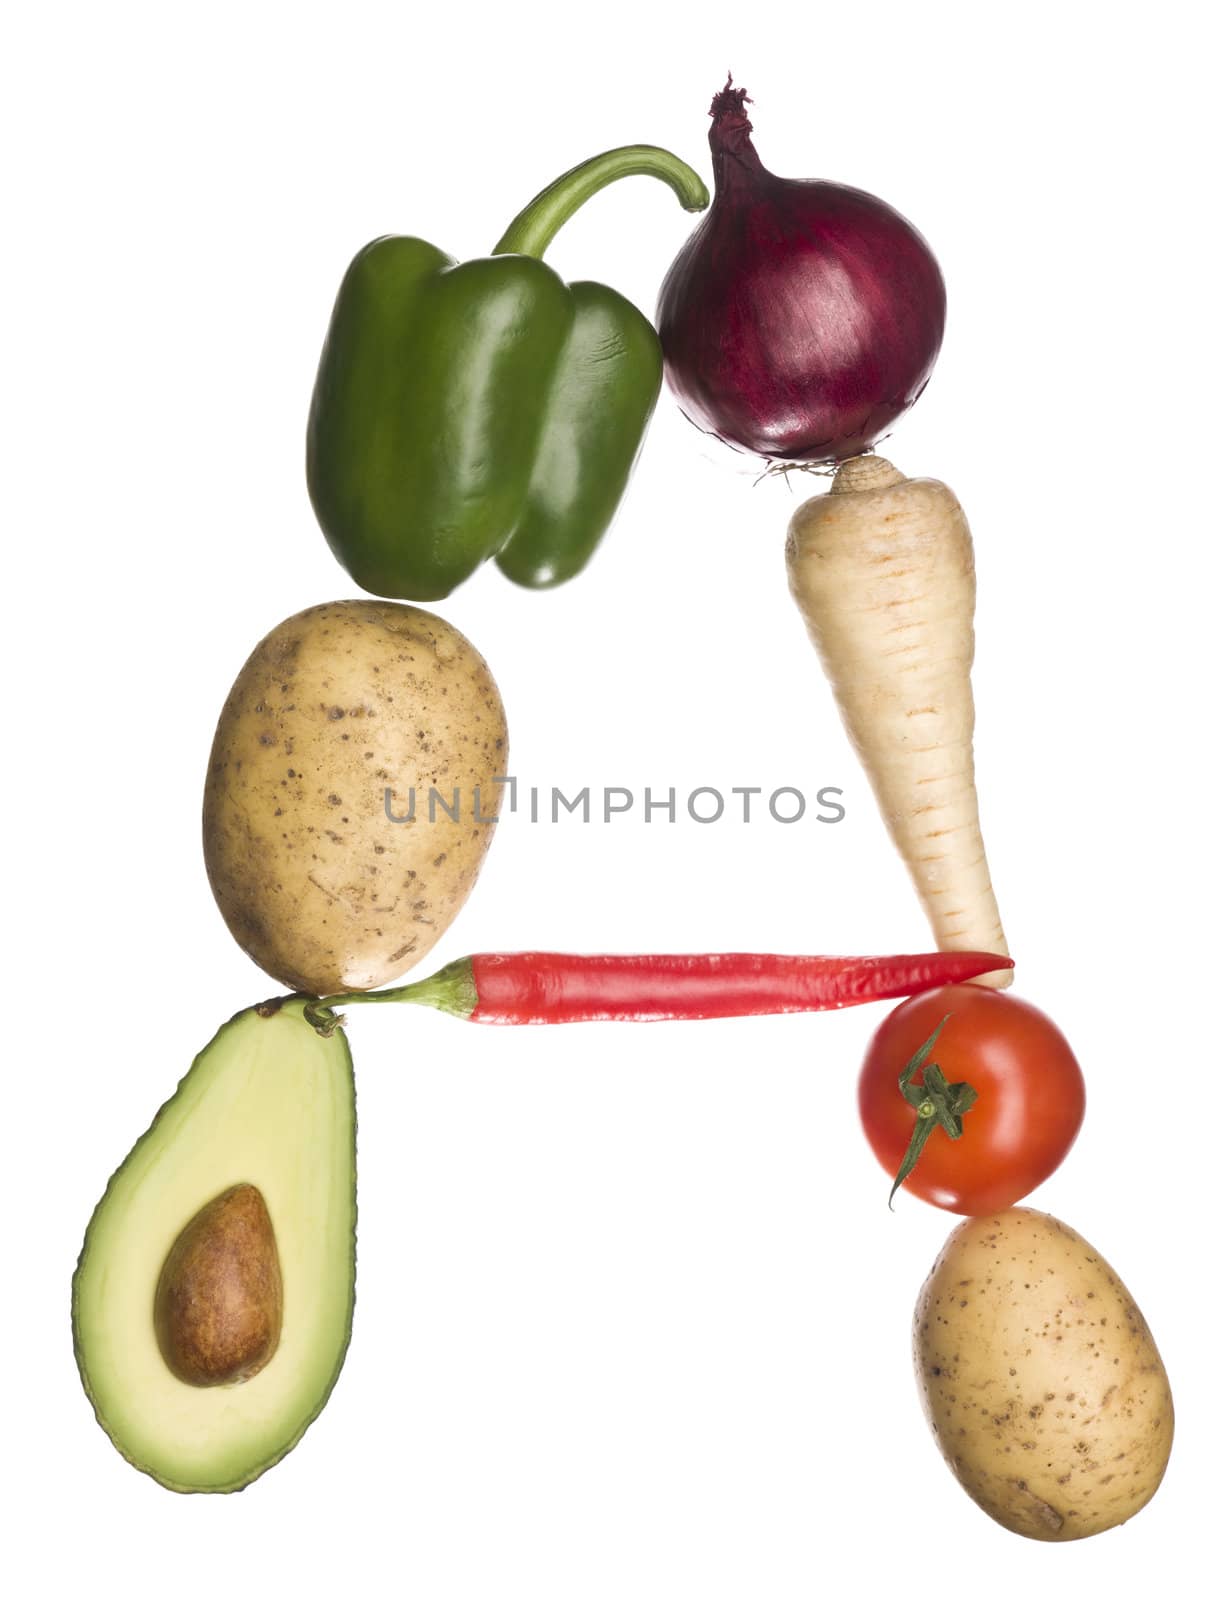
[787,456,1011,989]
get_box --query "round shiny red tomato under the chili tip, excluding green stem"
[859,984,1085,1216]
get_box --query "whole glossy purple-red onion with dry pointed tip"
[658,85,946,461]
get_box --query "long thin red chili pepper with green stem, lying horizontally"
[307,950,1013,1029]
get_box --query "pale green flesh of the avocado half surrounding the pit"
[72,1000,355,1493]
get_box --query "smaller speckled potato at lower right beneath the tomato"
[914,1206,1175,1541]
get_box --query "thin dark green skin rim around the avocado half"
[72,995,357,1494]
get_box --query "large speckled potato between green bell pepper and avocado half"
[203,600,509,995]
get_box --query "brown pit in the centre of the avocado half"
[154,1184,283,1389]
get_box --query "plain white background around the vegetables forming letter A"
[0,0,1219,1600]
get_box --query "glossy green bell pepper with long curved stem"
[306,144,707,600]
